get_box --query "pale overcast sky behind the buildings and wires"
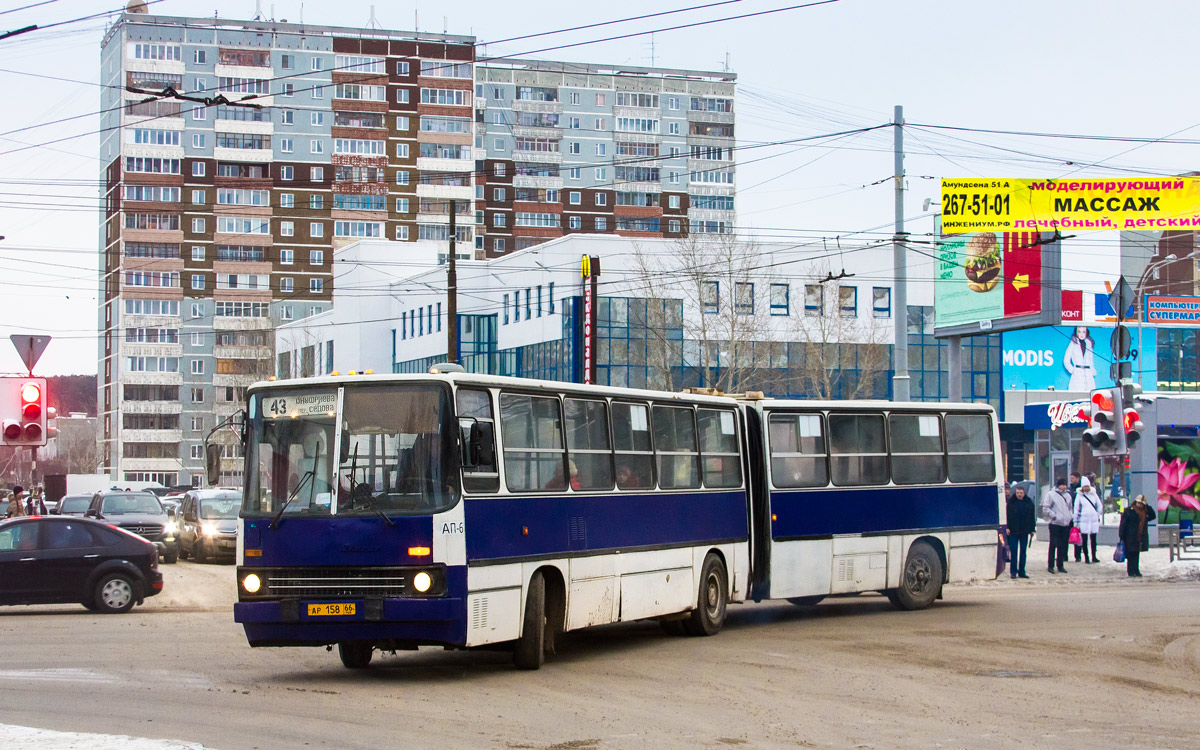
[0,0,1200,374]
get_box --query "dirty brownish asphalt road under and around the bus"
[0,563,1200,750]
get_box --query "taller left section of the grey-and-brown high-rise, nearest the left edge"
[98,13,474,485]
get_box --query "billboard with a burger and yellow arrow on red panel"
[934,226,1061,336]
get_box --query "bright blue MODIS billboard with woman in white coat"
[1001,325,1158,392]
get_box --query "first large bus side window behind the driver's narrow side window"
[500,394,566,492]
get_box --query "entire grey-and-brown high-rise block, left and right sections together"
[98,6,734,485]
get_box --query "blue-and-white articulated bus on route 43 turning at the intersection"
[234,366,1004,668]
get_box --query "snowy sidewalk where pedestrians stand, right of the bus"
[965,541,1200,587]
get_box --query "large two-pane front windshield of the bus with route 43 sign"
[244,384,458,517]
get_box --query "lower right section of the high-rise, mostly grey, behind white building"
[475,60,736,256]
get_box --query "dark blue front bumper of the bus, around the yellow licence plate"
[233,596,467,647]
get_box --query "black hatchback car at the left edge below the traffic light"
[0,516,162,614]
